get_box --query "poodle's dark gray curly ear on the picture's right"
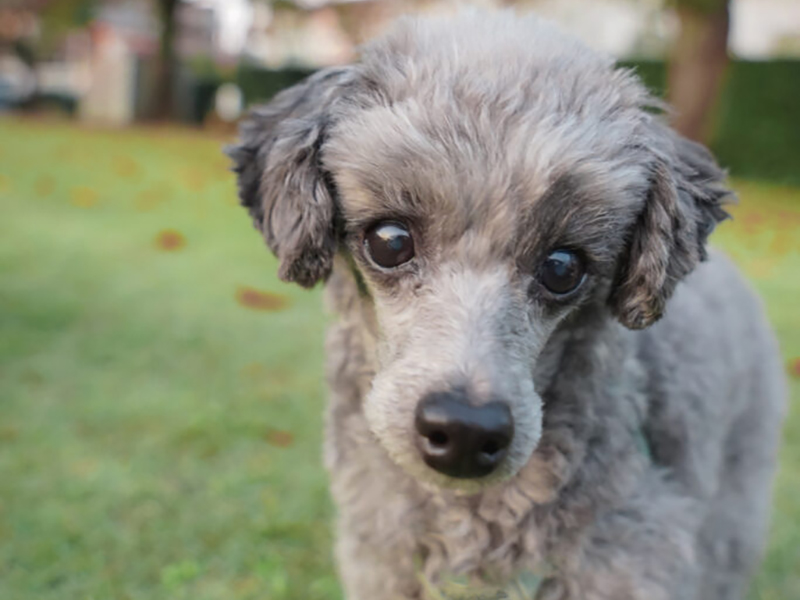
[610,123,732,329]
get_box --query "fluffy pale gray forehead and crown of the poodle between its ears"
[323,10,647,262]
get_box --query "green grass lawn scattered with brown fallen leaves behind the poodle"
[0,120,800,600]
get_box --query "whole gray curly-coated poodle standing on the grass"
[229,13,785,600]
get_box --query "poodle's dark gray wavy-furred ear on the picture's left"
[227,67,355,287]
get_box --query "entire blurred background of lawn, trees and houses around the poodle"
[0,0,800,600]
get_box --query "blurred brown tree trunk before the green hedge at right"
[667,0,730,142]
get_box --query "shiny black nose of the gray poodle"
[415,392,514,479]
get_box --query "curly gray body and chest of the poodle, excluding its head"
[326,247,782,600]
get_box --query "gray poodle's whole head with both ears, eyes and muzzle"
[231,14,728,490]
